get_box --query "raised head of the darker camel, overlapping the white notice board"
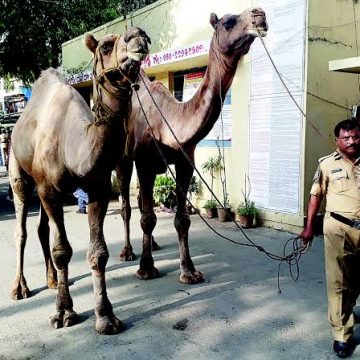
[210,8,268,56]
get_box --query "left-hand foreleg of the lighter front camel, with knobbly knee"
[37,184,78,329]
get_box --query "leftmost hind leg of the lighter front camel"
[9,154,34,300]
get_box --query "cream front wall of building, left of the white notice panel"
[62,0,252,211]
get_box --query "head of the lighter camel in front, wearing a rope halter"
[85,27,151,86]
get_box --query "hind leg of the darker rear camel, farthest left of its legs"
[115,159,136,261]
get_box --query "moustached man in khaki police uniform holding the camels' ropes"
[300,120,360,358]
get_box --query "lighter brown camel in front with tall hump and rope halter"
[9,28,150,334]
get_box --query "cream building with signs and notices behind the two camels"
[62,0,360,231]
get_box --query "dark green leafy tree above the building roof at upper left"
[0,0,122,83]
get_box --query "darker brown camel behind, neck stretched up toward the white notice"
[116,8,267,283]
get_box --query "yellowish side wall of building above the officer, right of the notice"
[303,0,360,217]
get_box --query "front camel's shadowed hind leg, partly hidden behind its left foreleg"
[38,205,57,289]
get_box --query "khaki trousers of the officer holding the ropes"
[324,214,360,341]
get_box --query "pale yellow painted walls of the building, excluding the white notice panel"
[63,0,360,232]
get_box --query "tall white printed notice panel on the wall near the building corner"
[249,0,305,214]
